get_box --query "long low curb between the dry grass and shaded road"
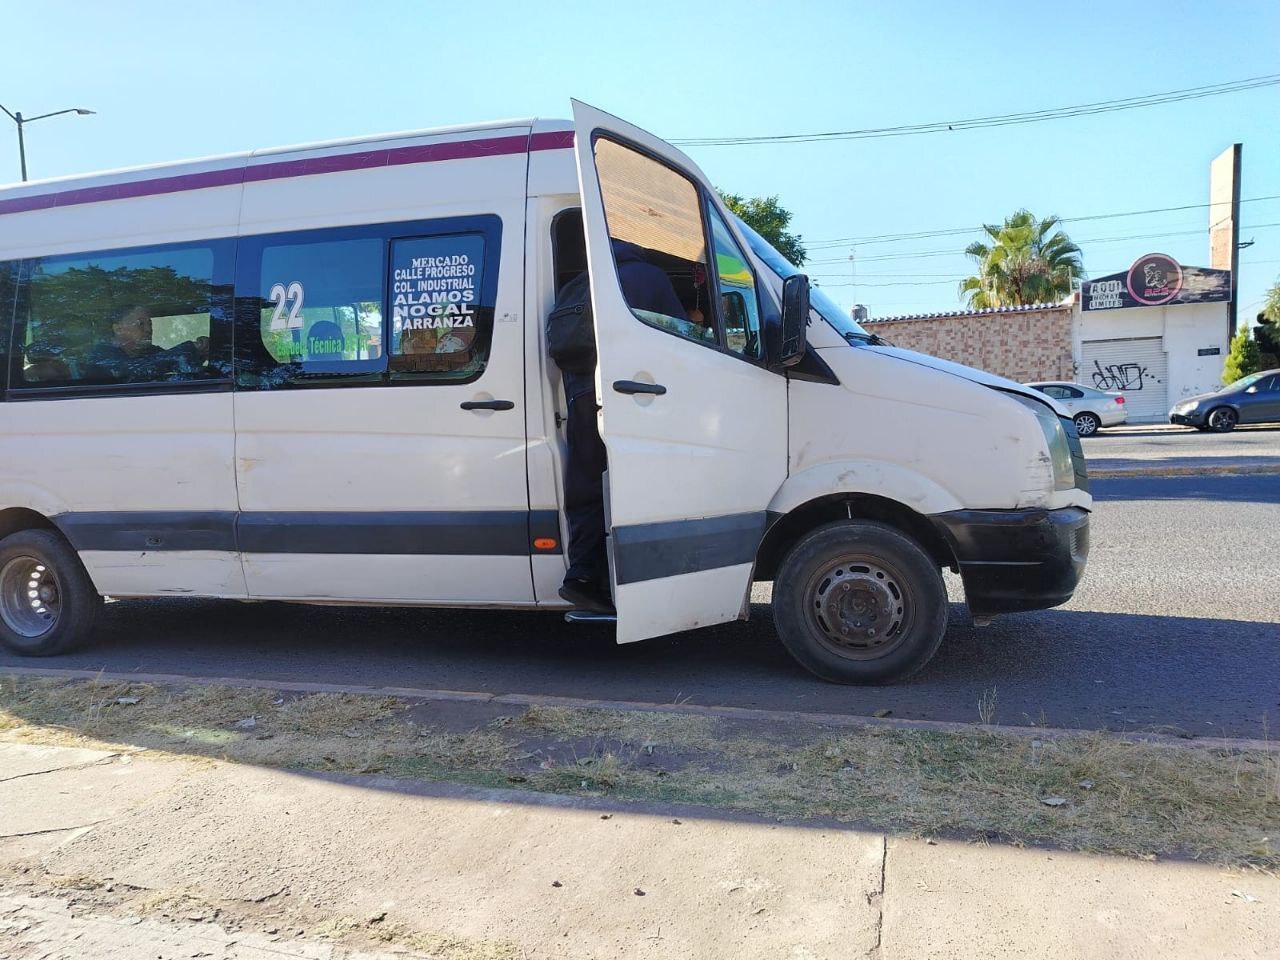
[0,667,1280,753]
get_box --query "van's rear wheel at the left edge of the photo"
[0,530,102,657]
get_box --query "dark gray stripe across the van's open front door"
[613,509,767,584]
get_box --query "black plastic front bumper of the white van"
[932,507,1089,617]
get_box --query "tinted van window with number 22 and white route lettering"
[236,216,502,389]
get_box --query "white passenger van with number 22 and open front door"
[0,102,1092,681]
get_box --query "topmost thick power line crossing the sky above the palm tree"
[671,73,1280,147]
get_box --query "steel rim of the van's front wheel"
[804,556,916,660]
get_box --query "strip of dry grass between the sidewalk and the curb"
[0,677,1280,869]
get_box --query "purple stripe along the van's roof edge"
[0,131,573,214]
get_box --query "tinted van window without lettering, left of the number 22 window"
[10,242,230,389]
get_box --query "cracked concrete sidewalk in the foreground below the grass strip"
[0,744,1280,960]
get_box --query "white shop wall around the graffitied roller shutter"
[1071,303,1230,406]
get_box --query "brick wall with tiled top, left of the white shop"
[868,302,1075,383]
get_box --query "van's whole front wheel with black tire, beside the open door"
[773,520,947,684]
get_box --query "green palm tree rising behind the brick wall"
[960,210,1084,310]
